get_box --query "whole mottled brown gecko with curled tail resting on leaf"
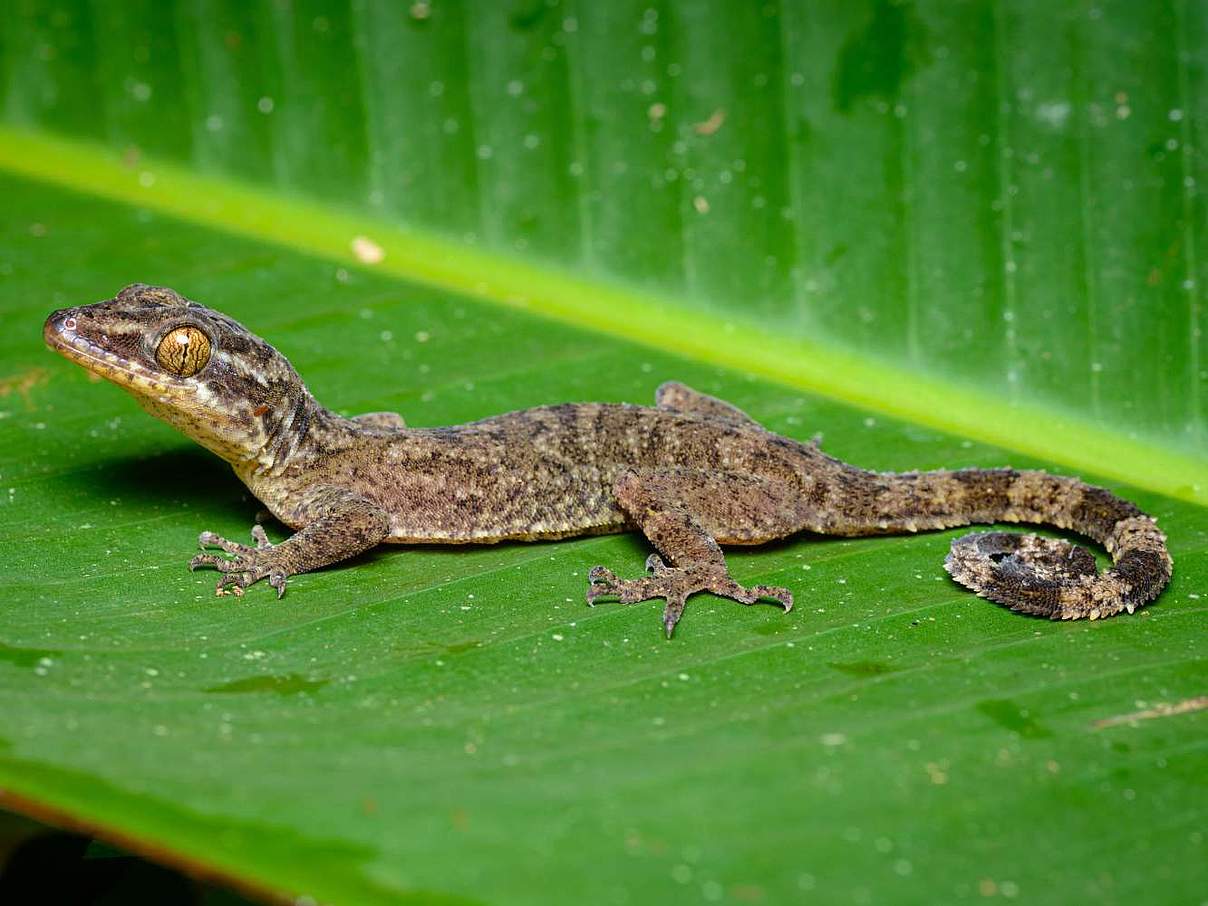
[43,284,1171,635]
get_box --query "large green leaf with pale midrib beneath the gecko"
[0,0,1208,902]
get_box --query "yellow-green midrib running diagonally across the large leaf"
[0,126,1208,505]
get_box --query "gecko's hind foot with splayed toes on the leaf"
[587,553,792,638]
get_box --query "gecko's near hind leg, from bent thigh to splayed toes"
[587,470,792,638]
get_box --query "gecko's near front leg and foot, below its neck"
[188,488,390,598]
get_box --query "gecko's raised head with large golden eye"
[42,283,310,463]
